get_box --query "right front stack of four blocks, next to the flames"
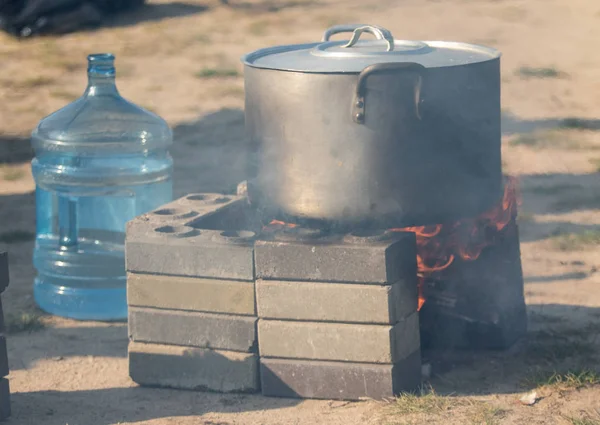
[255,233,421,400]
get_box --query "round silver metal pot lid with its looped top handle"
[242,25,500,73]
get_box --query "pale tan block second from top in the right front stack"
[256,280,417,324]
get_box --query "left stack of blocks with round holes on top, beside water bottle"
[126,194,260,392]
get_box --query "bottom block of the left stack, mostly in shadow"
[129,342,260,392]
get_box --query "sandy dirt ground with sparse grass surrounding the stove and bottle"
[0,0,600,425]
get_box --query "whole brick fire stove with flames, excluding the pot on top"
[126,179,526,400]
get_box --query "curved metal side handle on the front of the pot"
[352,62,425,124]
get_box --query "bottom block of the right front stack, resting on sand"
[260,350,421,400]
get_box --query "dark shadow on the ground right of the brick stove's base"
[424,304,600,395]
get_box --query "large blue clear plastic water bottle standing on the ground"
[32,54,173,320]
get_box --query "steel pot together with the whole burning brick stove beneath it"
[126,25,527,399]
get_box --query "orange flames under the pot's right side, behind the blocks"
[390,177,519,310]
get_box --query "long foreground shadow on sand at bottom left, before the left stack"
[11,387,300,425]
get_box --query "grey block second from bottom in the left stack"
[129,307,257,352]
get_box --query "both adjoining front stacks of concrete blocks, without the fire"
[126,194,421,400]
